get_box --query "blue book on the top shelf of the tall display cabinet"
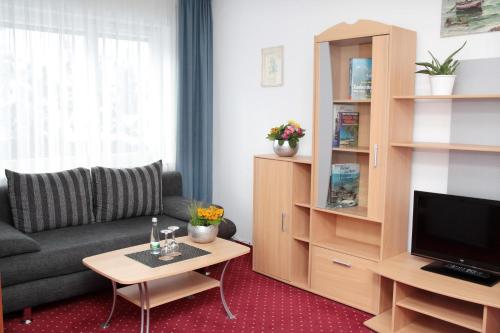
[349,58,372,100]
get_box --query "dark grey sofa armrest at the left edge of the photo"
[0,220,40,258]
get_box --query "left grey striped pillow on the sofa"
[5,168,95,233]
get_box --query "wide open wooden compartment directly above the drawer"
[311,210,382,261]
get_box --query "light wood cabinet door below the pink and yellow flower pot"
[253,158,292,280]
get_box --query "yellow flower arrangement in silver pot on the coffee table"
[188,202,224,243]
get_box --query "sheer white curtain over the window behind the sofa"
[0,0,177,173]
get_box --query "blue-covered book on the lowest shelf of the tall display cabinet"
[327,163,359,208]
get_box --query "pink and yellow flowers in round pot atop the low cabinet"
[266,120,306,157]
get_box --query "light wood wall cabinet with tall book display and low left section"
[253,20,416,316]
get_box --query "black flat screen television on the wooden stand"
[411,191,500,285]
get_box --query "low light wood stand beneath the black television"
[365,253,500,333]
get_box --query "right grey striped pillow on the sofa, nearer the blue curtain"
[91,160,163,222]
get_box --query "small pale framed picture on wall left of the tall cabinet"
[260,46,283,87]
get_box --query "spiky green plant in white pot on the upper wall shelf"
[416,41,467,95]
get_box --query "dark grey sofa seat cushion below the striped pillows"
[0,216,187,286]
